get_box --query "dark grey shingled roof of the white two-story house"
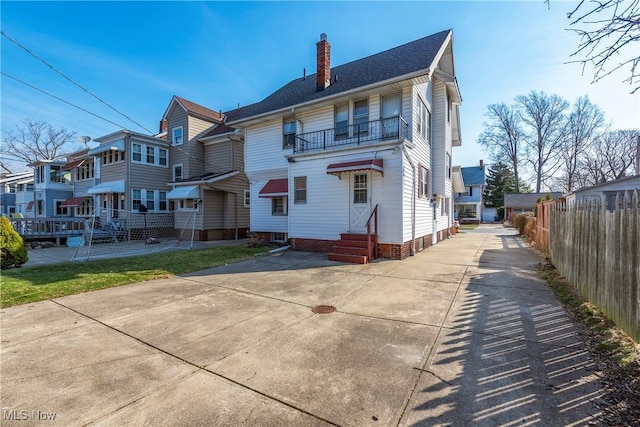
[226,30,451,124]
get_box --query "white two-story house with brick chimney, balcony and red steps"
[226,30,463,262]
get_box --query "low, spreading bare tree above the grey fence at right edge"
[579,130,640,186]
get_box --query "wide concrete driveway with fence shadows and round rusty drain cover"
[0,226,602,426]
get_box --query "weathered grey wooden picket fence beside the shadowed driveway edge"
[549,190,640,342]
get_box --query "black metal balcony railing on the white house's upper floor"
[293,116,409,153]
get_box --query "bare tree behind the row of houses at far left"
[0,119,77,164]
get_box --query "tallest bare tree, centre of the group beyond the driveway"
[516,91,569,193]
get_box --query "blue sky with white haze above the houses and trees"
[0,0,640,174]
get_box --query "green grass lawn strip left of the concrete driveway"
[0,246,268,307]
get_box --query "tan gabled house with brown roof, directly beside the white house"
[160,96,249,240]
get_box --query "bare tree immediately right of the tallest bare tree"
[561,95,604,192]
